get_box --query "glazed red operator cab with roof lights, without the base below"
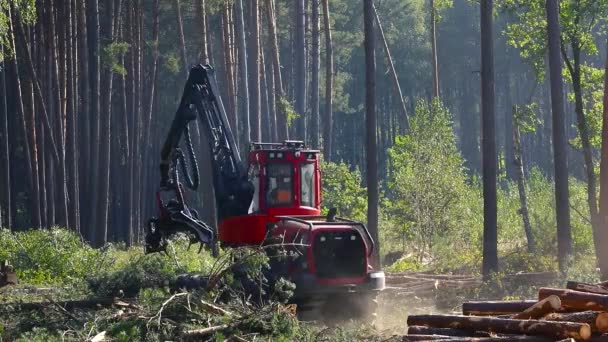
[249,140,321,215]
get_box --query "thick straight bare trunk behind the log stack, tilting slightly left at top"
[545,0,572,271]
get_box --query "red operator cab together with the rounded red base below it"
[218,140,321,246]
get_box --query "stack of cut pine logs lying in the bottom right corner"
[403,281,608,342]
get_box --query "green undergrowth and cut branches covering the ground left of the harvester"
[0,228,380,342]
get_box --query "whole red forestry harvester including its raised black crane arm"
[146,65,385,318]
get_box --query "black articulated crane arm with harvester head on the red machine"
[146,65,254,252]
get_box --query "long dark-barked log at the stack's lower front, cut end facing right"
[407,315,591,340]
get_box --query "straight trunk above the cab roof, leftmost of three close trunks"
[294,0,306,141]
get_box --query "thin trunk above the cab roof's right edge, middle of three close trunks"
[310,0,320,148]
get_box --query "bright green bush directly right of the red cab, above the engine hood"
[321,161,367,221]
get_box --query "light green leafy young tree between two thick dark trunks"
[389,100,471,260]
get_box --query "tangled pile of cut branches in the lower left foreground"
[0,244,304,341]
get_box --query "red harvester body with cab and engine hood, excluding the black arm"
[218,141,384,302]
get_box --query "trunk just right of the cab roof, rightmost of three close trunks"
[321,0,334,160]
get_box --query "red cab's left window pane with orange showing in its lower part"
[266,163,293,207]
